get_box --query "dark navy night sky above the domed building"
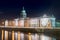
[0,0,60,20]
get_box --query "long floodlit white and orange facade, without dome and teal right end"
[0,18,51,27]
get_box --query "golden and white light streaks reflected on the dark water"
[2,30,56,40]
